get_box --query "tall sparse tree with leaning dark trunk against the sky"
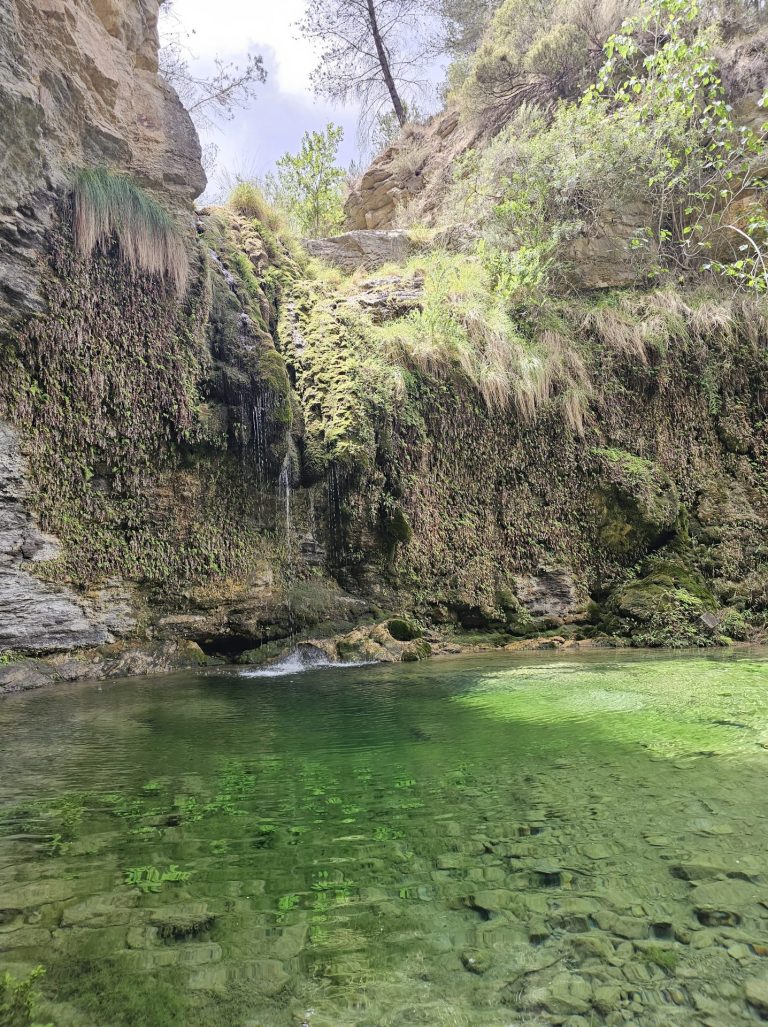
[300,0,433,136]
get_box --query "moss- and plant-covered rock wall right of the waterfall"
[282,271,768,644]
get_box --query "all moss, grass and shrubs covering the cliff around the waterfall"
[0,0,768,665]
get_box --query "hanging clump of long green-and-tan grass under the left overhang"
[73,167,189,294]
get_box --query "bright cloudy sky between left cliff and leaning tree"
[165,0,358,199]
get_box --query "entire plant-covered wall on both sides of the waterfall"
[0,193,768,657]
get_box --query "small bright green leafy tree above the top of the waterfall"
[264,123,347,238]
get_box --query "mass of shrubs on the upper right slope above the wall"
[444,0,768,292]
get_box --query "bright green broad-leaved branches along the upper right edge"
[583,0,768,291]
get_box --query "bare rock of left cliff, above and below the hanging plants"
[0,0,205,651]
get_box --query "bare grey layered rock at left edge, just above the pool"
[0,421,111,652]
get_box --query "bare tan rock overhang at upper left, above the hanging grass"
[0,0,205,329]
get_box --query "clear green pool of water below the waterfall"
[0,650,768,1027]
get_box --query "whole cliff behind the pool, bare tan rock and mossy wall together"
[0,0,768,688]
